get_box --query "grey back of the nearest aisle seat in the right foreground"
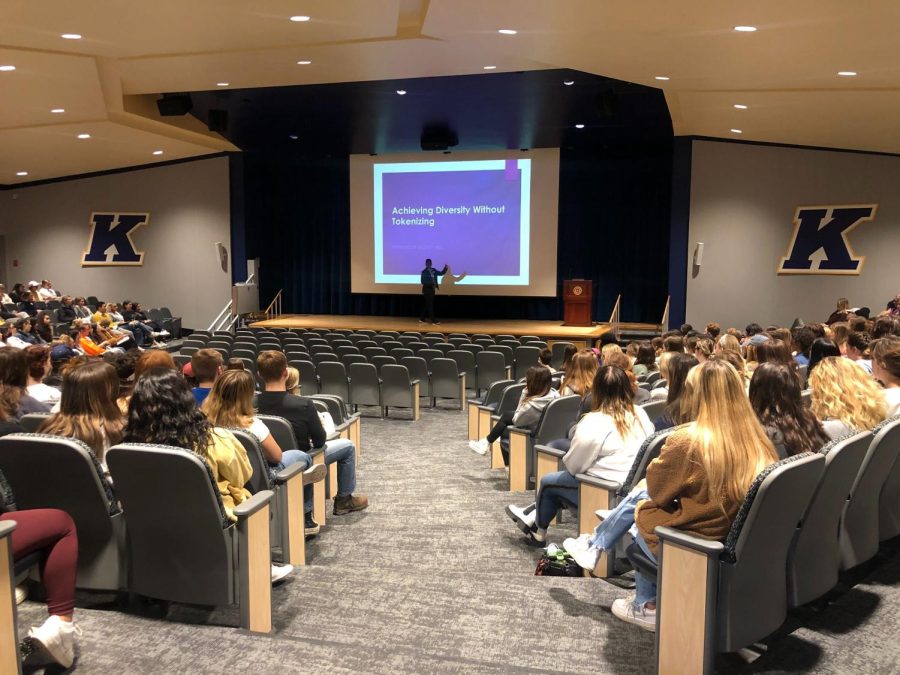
[716,453,825,652]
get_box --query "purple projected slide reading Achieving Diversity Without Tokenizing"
[373,159,531,286]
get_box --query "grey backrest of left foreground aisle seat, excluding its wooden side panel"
[107,444,235,605]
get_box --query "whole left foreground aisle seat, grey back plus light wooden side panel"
[107,444,273,633]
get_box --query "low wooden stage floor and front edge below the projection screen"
[251,314,659,343]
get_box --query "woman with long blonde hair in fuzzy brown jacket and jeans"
[563,360,778,631]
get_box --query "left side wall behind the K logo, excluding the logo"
[0,157,231,328]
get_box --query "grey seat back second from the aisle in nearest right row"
[788,431,872,607]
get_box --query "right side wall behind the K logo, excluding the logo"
[686,141,900,328]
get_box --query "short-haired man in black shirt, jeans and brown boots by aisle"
[256,350,368,516]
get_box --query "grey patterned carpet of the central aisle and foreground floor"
[19,404,900,675]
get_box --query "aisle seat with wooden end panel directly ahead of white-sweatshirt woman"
[510,396,581,492]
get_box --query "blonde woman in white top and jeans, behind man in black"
[200,364,325,536]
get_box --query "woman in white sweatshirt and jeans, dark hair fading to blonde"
[506,365,653,544]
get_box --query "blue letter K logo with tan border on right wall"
[778,204,878,274]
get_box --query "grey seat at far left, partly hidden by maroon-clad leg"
[0,434,125,591]
